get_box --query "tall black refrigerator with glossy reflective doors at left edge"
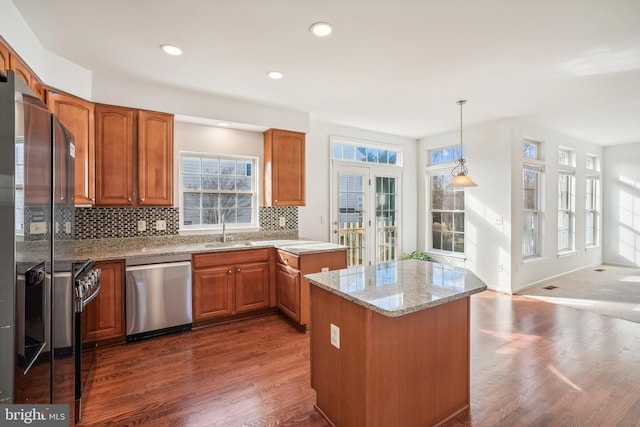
[0,71,76,414]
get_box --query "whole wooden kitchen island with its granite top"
[305,260,487,427]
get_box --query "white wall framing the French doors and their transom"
[298,121,418,247]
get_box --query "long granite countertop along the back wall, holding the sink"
[17,235,346,261]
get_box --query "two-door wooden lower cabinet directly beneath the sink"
[192,249,275,323]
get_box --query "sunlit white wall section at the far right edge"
[602,143,640,267]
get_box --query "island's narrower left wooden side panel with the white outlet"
[310,286,368,427]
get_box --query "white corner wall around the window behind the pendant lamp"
[418,121,511,292]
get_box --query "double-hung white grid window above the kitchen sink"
[180,152,258,230]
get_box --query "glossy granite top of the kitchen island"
[304,259,487,317]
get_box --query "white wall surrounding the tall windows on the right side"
[510,120,603,293]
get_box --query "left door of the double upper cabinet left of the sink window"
[95,104,136,206]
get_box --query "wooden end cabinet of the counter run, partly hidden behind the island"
[276,249,347,331]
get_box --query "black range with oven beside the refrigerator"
[74,259,102,422]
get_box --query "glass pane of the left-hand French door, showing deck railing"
[338,174,365,266]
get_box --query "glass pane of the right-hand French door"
[375,177,398,262]
